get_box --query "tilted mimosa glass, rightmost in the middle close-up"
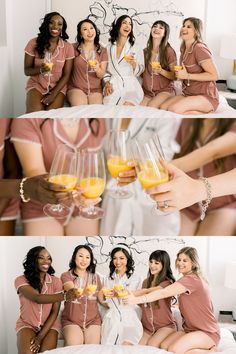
[132,135,169,215]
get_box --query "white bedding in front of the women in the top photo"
[19,96,236,118]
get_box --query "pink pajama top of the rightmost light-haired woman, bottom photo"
[177,273,220,345]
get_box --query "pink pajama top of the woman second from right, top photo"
[142,46,176,97]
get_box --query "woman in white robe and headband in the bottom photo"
[101,243,143,345]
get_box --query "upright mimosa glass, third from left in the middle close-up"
[107,130,133,199]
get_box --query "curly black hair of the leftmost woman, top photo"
[36,11,69,58]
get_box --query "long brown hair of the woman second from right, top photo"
[145,20,170,69]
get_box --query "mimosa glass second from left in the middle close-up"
[77,149,106,219]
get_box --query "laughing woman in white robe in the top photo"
[103,15,144,105]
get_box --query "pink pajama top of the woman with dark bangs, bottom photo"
[141,279,176,334]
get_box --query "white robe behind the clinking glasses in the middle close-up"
[100,118,180,236]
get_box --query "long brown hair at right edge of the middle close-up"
[175,118,236,172]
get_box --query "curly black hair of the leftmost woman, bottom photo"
[23,246,55,292]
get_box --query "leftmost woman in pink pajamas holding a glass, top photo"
[24,12,74,113]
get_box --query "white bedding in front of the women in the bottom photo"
[44,328,236,354]
